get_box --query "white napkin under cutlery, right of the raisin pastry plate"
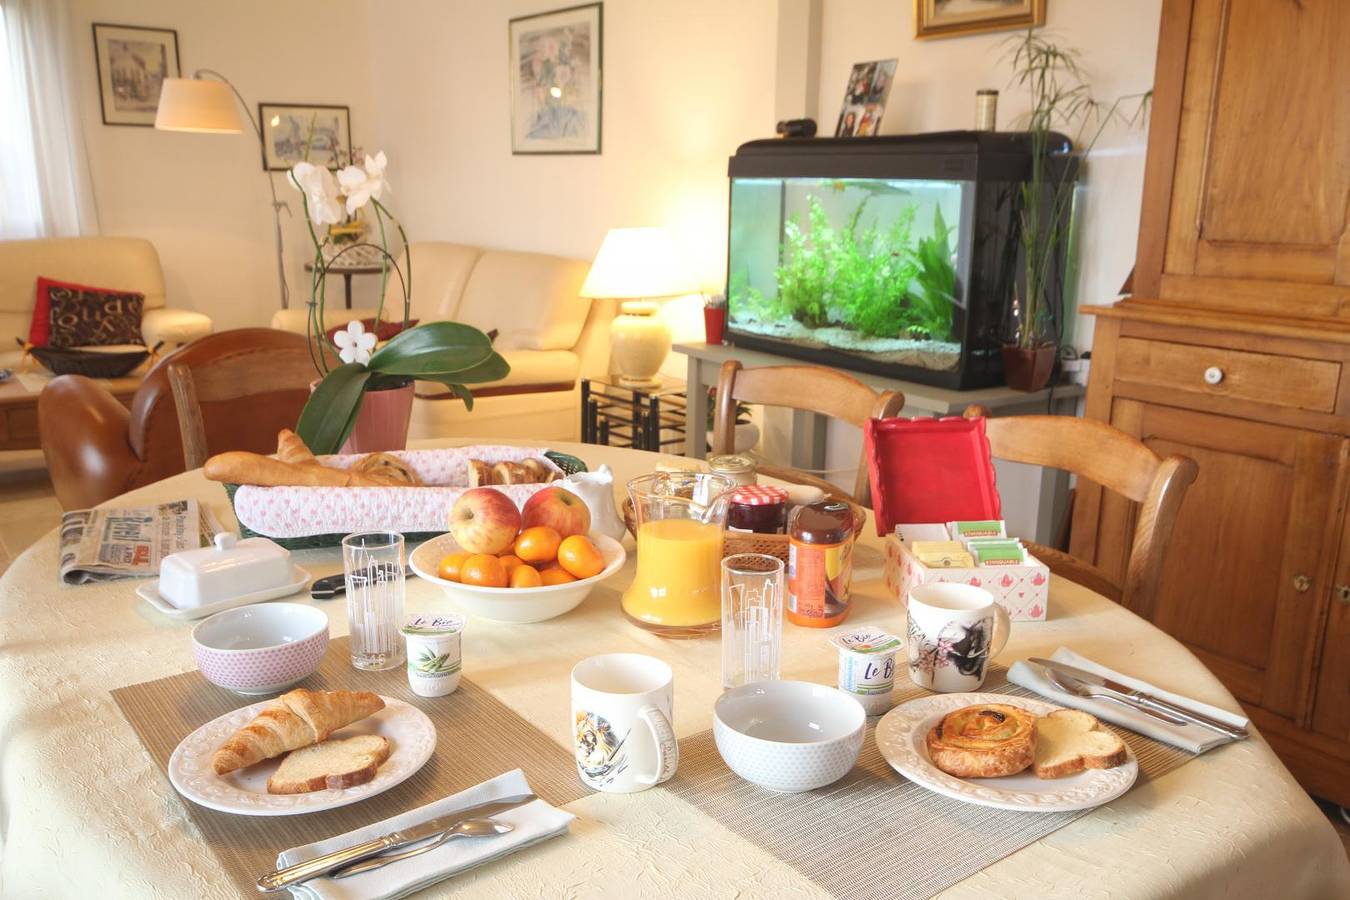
[1008,646,1249,753]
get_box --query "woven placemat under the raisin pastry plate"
[664,667,1192,900]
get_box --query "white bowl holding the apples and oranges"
[408,533,628,623]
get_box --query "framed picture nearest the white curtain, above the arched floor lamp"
[93,22,182,128]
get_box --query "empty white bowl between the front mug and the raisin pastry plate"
[713,681,867,792]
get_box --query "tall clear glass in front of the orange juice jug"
[722,553,783,688]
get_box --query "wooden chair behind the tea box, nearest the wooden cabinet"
[965,406,1199,618]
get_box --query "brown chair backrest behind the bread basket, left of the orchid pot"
[165,328,317,468]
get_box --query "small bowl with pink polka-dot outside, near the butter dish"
[192,603,328,696]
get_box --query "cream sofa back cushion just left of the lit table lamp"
[455,250,590,351]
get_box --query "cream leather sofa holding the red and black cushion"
[0,237,211,368]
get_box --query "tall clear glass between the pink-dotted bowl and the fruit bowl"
[342,532,404,669]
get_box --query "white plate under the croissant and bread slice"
[169,696,436,815]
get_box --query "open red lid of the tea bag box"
[863,416,1002,534]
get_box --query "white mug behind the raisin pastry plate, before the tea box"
[907,582,1011,694]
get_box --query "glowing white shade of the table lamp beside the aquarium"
[581,228,698,300]
